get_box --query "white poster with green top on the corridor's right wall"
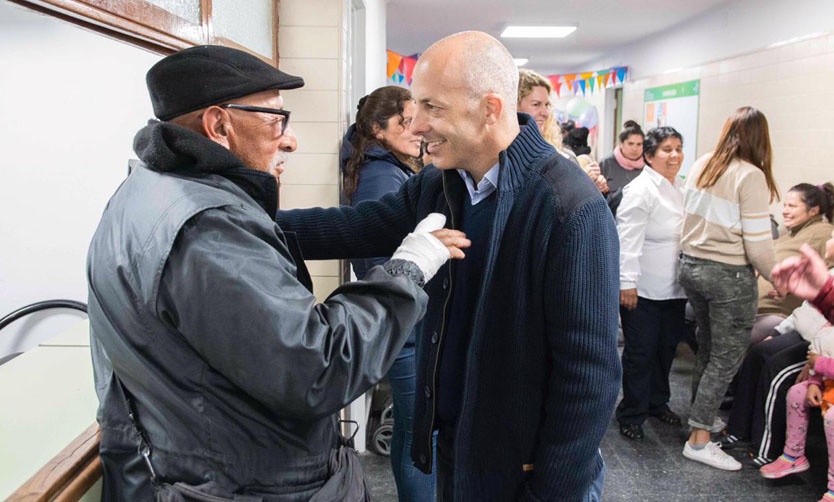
[643,80,701,177]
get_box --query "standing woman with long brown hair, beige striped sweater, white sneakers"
[679,107,779,471]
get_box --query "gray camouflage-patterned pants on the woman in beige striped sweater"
[679,255,758,429]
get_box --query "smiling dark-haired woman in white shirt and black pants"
[617,127,686,440]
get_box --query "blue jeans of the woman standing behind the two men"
[388,343,435,502]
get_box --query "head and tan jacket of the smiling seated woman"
[750,183,834,344]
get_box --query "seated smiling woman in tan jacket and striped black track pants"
[721,183,834,466]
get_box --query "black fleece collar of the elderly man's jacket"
[133,120,278,217]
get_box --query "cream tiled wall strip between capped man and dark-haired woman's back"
[278,0,347,300]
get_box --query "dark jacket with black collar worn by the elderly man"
[88,122,426,500]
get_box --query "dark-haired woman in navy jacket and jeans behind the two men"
[341,85,435,501]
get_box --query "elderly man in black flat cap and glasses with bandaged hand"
[88,46,469,501]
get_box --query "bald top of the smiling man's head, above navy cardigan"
[415,31,518,115]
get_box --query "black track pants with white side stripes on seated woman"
[727,331,809,460]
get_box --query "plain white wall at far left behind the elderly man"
[0,0,159,358]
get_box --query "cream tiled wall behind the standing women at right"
[623,35,834,226]
